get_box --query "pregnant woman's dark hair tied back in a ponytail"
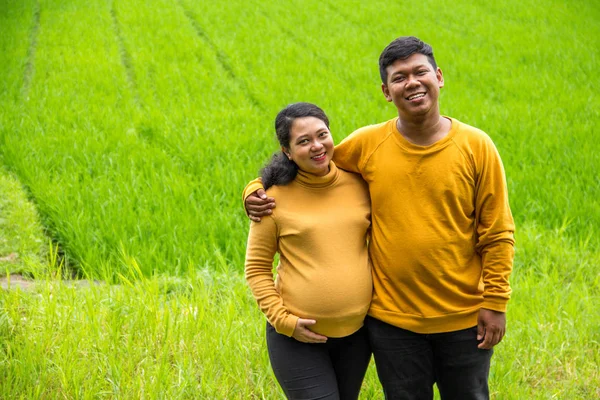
[260,103,329,190]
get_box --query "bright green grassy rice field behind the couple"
[0,0,600,399]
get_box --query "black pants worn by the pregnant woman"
[267,323,371,400]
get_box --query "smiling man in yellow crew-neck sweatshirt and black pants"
[246,37,514,400]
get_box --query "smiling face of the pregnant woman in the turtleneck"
[282,117,333,176]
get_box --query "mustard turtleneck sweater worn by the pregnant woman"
[246,162,373,337]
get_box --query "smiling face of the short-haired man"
[381,53,444,119]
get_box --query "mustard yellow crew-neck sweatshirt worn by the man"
[244,118,514,333]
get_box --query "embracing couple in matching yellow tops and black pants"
[244,37,514,400]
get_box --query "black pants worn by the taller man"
[365,317,492,400]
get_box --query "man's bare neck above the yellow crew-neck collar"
[396,114,452,146]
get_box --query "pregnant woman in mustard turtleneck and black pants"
[244,103,373,400]
